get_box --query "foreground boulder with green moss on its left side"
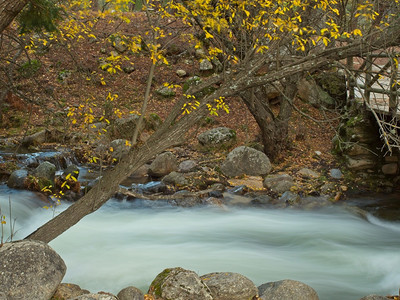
[148,268,212,300]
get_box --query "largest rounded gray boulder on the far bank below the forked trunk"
[221,146,272,177]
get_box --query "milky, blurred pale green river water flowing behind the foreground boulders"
[0,187,400,300]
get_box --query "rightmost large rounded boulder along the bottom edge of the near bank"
[258,279,319,300]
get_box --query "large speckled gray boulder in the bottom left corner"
[0,240,67,300]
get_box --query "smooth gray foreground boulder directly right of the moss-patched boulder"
[200,272,258,300]
